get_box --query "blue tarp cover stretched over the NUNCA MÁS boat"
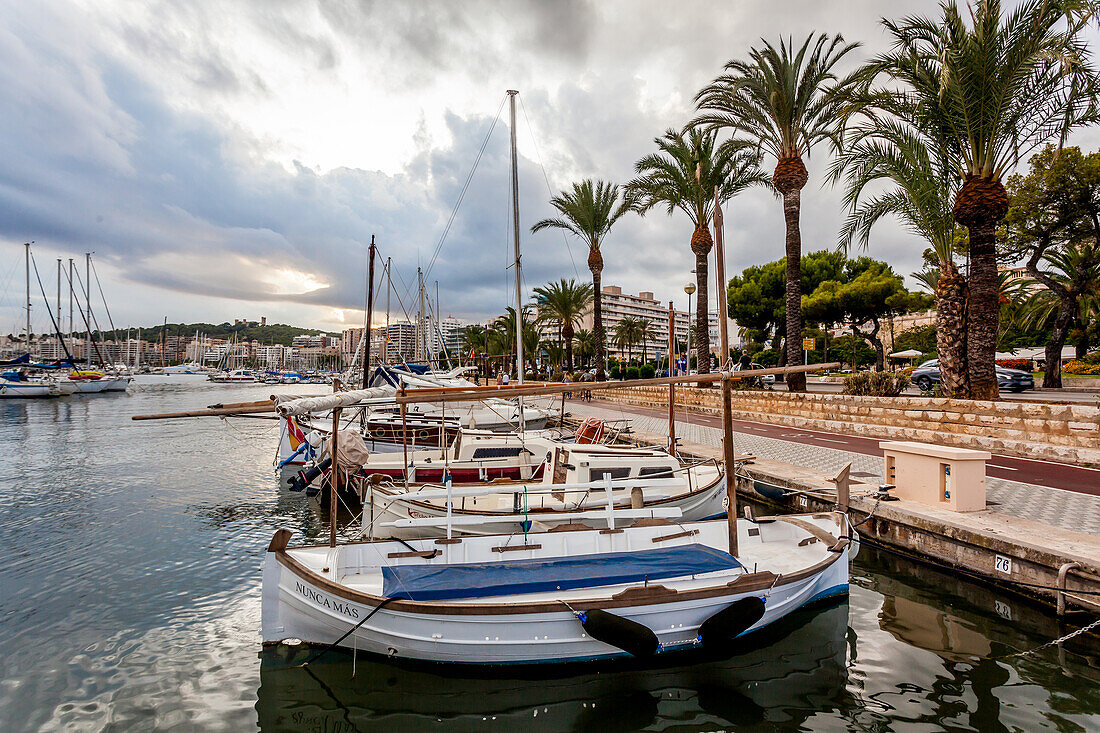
[382,545,744,601]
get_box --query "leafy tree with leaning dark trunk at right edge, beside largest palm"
[1004,145,1100,387]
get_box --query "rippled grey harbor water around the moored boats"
[0,375,1100,733]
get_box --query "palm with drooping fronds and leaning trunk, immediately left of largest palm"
[829,114,969,397]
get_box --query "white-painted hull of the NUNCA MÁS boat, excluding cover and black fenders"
[262,515,848,665]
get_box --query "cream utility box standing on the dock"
[879,441,991,512]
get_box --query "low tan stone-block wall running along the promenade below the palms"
[601,387,1100,466]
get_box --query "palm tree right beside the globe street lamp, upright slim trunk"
[628,127,767,372]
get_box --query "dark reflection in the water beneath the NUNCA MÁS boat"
[256,602,848,731]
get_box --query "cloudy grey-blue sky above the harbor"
[0,0,1100,332]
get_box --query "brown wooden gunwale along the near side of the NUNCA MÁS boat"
[268,516,844,616]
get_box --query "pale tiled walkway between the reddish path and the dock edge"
[567,402,1100,535]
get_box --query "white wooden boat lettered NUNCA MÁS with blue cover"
[262,510,849,664]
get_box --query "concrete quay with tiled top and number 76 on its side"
[567,402,1100,615]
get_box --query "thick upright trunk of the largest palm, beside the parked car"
[966,220,1001,400]
